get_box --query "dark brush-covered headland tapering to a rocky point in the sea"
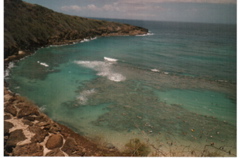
[4,0,148,58]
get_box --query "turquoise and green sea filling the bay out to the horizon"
[5,19,236,156]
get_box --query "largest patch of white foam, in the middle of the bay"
[75,61,126,82]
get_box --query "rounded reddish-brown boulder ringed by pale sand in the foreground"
[46,134,63,149]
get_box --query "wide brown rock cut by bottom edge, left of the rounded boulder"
[13,143,43,156]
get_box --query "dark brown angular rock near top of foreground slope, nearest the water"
[18,104,39,118]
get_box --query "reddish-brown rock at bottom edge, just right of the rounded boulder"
[62,137,85,156]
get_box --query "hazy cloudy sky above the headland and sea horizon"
[24,0,236,24]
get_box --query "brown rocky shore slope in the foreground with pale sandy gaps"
[4,88,122,156]
